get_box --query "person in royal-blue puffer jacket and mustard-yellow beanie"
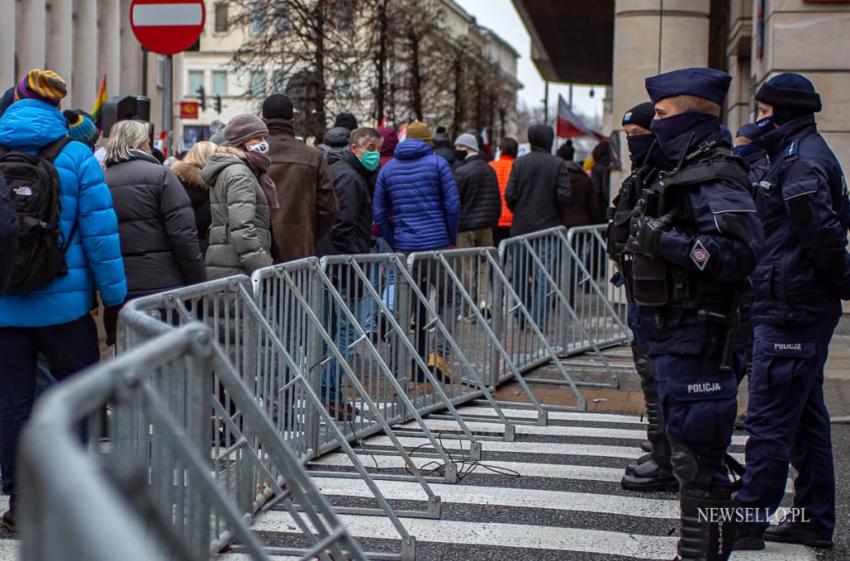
[372,121,460,382]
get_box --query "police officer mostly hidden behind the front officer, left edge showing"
[607,101,679,491]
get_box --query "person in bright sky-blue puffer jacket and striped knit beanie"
[0,69,127,529]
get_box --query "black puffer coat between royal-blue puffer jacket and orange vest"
[454,154,502,232]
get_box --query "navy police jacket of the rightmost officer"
[752,115,850,326]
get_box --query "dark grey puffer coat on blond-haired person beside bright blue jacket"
[104,151,207,298]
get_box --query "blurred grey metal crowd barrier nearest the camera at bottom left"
[19,317,366,561]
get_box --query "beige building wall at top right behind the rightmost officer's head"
[752,0,850,172]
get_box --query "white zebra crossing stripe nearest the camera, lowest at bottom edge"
[253,511,815,561]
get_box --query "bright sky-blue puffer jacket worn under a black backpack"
[0,99,127,327]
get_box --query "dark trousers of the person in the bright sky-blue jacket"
[0,314,100,504]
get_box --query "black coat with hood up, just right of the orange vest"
[505,125,570,236]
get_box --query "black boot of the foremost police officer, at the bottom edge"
[678,489,735,561]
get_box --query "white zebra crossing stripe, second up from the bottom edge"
[313,477,679,519]
